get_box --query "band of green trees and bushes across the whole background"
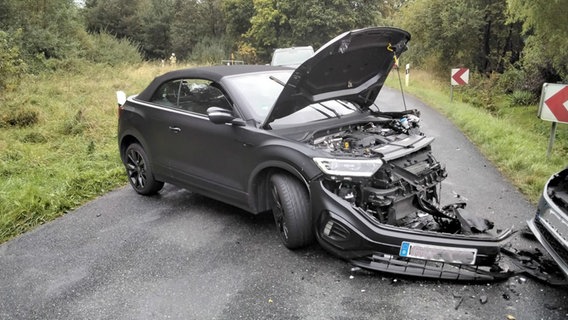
[0,0,568,87]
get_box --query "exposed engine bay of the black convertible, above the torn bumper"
[312,112,493,234]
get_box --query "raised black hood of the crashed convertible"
[262,27,410,128]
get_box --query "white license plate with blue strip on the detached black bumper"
[399,241,477,264]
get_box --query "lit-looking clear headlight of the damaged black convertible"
[314,158,383,177]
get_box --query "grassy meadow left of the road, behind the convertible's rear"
[0,64,182,243]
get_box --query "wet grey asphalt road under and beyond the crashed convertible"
[0,89,568,319]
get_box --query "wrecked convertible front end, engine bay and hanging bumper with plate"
[310,110,512,280]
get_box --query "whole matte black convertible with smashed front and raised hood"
[118,27,512,280]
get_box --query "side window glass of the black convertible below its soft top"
[150,79,233,114]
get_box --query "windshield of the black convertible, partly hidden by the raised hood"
[224,70,359,127]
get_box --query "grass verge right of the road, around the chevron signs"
[387,70,568,203]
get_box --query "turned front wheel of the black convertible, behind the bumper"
[270,173,314,249]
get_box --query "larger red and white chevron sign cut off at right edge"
[538,83,568,123]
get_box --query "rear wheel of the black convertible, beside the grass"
[124,143,164,196]
